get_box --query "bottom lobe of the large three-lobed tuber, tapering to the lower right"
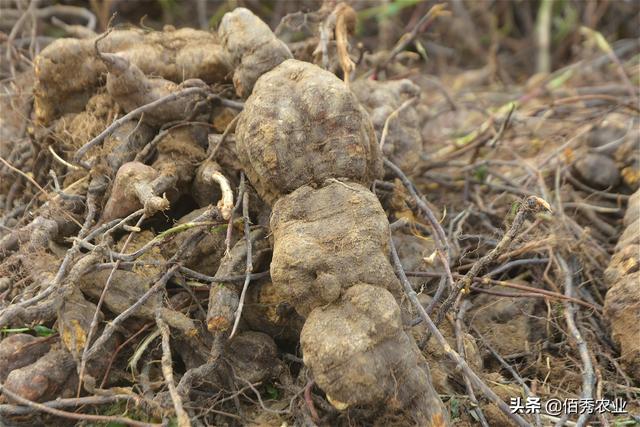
[300,284,445,425]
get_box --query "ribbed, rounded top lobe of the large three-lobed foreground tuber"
[236,59,382,204]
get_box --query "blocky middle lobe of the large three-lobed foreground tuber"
[271,182,399,316]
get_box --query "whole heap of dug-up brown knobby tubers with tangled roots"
[0,8,448,426]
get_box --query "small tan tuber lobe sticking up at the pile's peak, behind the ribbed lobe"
[218,7,293,98]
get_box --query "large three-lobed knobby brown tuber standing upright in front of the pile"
[236,54,447,425]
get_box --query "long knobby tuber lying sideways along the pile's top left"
[34,28,231,125]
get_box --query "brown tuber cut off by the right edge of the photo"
[604,190,640,381]
